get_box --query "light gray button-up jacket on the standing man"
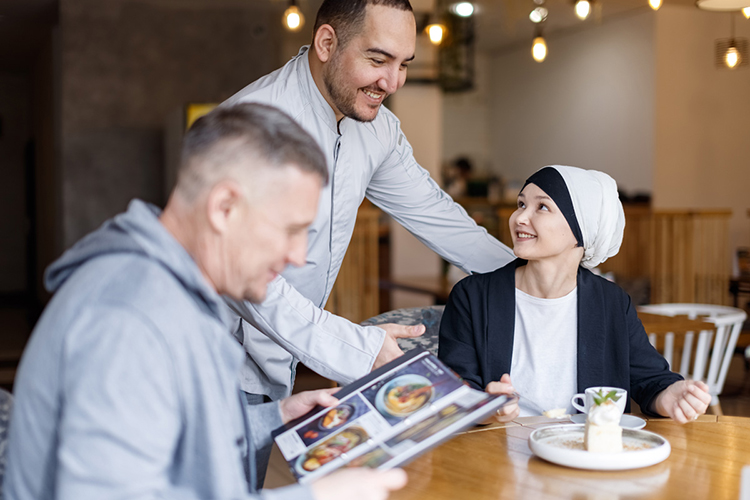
[225,47,515,399]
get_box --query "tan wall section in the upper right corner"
[654,5,750,256]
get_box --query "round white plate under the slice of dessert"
[529,424,672,470]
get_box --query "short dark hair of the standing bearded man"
[313,0,414,47]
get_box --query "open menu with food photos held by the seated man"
[273,348,510,483]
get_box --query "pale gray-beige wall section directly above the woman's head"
[488,8,655,192]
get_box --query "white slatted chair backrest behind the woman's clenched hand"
[639,304,747,404]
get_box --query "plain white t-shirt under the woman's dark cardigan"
[510,288,578,417]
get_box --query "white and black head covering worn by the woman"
[522,165,625,269]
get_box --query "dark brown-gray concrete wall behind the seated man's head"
[60,0,283,247]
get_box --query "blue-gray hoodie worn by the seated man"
[4,200,312,500]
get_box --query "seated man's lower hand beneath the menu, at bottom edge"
[311,469,407,500]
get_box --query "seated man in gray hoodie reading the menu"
[5,104,406,500]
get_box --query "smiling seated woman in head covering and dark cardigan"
[439,166,711,423]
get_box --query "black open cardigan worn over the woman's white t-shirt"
[438,259,682,415]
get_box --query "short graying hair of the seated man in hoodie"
[175,103,328,201]
